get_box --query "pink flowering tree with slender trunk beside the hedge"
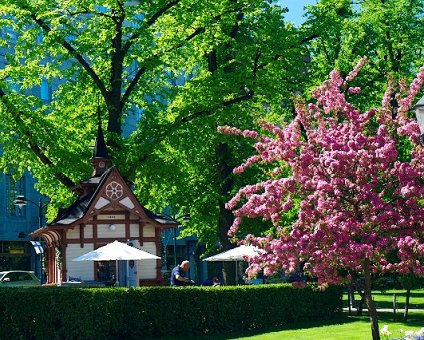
[219,58,424,339]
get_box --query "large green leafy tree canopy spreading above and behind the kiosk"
[0,0,305,270]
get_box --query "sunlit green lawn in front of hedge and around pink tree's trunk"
[170,289,424,340]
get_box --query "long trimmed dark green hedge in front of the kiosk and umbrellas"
[0,285,342,339]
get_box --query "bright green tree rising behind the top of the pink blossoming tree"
[302,0,424,107]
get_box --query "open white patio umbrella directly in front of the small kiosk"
[72,241,160,285]
